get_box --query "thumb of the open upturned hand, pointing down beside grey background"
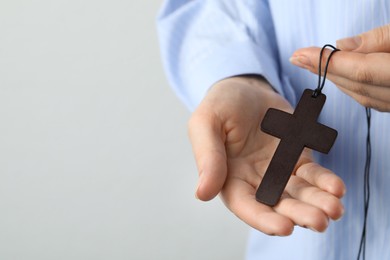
[188,111,227,201]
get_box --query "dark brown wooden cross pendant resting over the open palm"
[256,89,337,206]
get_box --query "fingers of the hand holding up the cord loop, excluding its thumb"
[290,47,390,111]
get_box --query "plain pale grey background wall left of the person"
[0,0,248,260]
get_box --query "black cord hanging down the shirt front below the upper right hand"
[357,108,371,260]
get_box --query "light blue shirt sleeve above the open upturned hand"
[158,0,283,110]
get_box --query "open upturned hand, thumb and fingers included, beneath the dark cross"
[189,77,345,235]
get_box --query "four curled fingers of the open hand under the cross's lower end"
[221,172,344,236]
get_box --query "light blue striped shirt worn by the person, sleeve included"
[158,0,390,260]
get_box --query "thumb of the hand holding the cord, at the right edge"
[337,24,390,53]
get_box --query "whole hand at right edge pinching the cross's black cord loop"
[290,25,390,112]
